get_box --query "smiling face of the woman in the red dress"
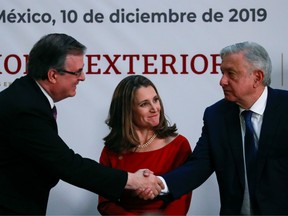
[132,86,161,129]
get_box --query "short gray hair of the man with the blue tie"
[220,41,272,86]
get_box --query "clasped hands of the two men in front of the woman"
[125,169,165,200]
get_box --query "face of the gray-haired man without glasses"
[220,52,258,108]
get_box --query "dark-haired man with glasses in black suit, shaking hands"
[0,34,161,215]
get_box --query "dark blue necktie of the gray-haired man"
[241,110,257,209]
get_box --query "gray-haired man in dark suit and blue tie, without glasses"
[162,42,288,215]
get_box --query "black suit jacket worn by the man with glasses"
[0,75,127,215]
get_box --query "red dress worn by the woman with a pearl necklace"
[98,135,192,215]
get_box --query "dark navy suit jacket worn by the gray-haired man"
[163,87,288,215]
